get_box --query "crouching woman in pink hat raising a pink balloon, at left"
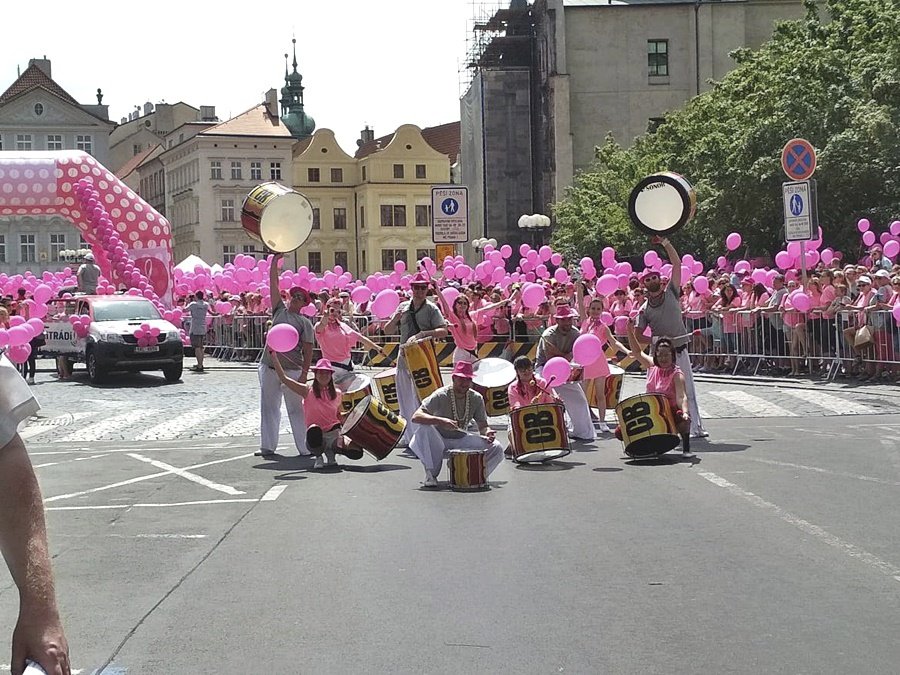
[272,352,363,470]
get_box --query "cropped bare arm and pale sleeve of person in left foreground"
[0,353,70,675]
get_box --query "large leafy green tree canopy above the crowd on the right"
[553,0,900,270]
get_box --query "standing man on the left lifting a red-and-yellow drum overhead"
[258,253,315,457]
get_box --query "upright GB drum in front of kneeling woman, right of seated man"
[509,403,571,462]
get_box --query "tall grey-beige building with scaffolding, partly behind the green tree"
[461,0,805,252]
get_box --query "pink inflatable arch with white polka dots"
[0,150,173,304]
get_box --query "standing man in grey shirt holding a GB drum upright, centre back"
[384,273,447,445]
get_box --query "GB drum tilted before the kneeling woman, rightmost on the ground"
[616,394,681,459]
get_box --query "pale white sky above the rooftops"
[0,0,492,155]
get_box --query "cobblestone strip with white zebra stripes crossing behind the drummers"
[22,359,900,445]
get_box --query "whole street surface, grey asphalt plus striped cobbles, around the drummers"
[0,367,900,675]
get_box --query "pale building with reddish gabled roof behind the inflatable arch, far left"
[0,58,115,274]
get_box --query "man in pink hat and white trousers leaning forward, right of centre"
[535,305,597,441]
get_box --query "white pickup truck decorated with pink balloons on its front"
[41,295,184,384]
